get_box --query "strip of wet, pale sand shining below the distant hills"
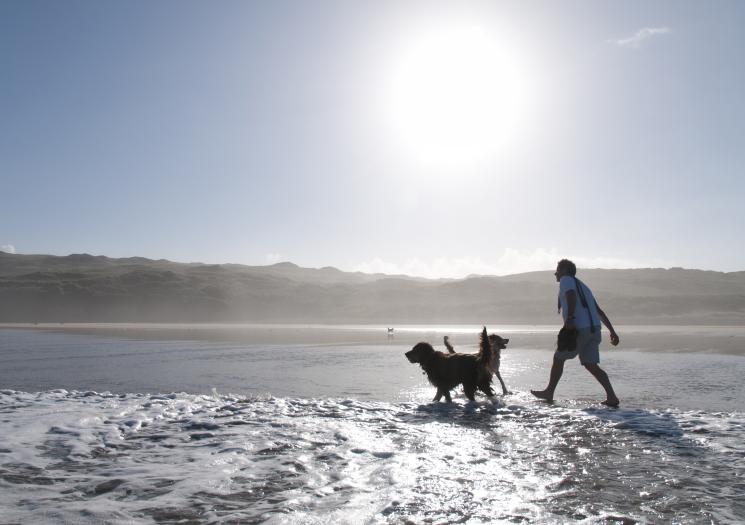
[0,323,745,355]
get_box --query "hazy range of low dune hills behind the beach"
[0,252,745,325]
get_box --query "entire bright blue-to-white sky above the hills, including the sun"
[0,0,745,277]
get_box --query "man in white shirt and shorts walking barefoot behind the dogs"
[531,259,619,407]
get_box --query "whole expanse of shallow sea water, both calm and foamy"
[0,331,745,524]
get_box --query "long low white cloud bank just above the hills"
[352,248,665,279]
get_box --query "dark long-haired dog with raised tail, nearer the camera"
[405,327,494,403]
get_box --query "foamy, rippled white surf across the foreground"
[0,390,745,524]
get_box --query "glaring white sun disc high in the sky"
[387,27,527,167]
